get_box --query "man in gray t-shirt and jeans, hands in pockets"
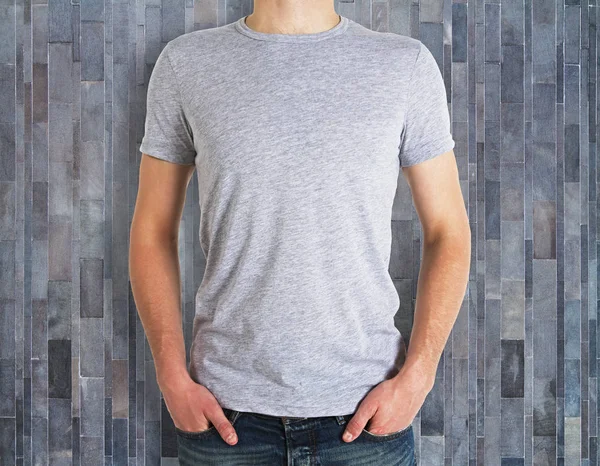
[130,0,470,466]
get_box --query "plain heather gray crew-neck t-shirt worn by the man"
[140,16,454,417]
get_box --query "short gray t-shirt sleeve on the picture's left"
[140,44,196,165]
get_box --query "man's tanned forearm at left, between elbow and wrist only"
[129,234,188,385]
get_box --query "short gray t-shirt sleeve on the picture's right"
[400,42,454,167]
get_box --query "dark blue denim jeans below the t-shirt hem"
[176,408,417,466]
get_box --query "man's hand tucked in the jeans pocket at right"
[342,369,430,442]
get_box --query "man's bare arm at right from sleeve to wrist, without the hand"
[401,151,471,388]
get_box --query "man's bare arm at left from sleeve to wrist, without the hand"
[129,154,194,390]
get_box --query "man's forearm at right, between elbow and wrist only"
[402,228,471,388]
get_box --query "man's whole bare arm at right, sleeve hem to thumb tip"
[343,150,471,441]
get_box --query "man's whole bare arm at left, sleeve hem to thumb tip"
[129,154,237,445]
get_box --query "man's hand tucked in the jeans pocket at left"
[161,376,238,445]
